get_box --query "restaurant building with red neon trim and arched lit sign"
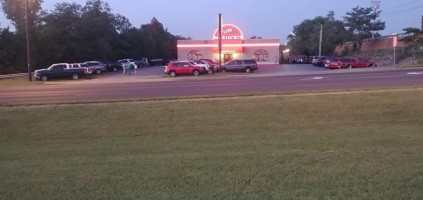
[177,24,280,64]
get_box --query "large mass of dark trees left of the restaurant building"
[0,0,190,74]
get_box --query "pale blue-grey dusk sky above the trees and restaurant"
[0,0,423,43]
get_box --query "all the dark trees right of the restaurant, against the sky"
[287,6,423,59]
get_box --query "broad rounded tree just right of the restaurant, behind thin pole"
[287,11,350,56]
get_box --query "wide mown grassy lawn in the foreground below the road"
[0,90,423,199]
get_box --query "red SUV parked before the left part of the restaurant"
[165,61,206,77]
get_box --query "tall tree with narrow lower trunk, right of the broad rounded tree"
[344,6,385,54]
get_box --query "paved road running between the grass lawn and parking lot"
[0,69,423,103]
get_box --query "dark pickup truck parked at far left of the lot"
[34,63,90,81]
